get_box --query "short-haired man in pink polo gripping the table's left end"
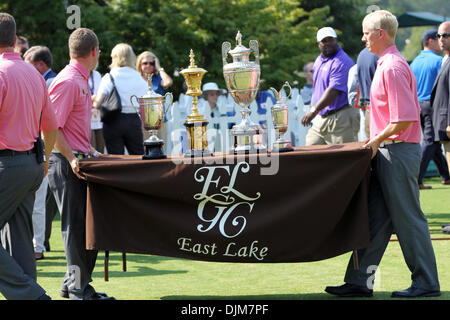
[48,28,114,300]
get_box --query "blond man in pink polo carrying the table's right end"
[325,10,440,298]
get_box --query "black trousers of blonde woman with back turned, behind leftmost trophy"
[103,113,144,155]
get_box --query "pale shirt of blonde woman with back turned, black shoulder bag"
[98,67,148,113]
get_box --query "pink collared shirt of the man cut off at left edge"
[0,52,57,151]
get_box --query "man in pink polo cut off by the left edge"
[0,13,56,300]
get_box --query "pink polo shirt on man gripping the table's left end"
[48,60,92,153]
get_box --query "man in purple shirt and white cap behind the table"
[302,27,359,145]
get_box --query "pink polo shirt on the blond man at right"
[370,45,421,143]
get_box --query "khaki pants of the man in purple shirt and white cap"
[306,106,360,146]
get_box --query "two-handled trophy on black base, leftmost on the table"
[130,75,173,160]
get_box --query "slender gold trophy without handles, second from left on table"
[180,49,212,157]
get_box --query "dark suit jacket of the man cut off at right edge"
[431,58,450,141]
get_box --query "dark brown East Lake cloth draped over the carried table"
[80,143,371,263]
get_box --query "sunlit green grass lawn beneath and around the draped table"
[0,178,450,300]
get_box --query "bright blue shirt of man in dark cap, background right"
[411,50,442,102]
